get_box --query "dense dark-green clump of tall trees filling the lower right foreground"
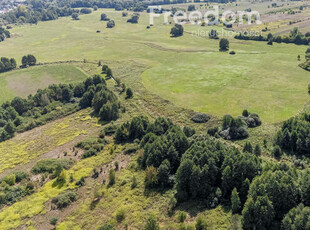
[115,116,310,229]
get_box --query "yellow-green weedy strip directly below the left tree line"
[0,111,88,172]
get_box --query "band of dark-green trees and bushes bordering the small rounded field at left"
[0,75,120,141]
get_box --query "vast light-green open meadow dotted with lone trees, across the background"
[0,10,309,122]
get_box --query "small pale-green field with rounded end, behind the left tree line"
[0,64,87,103]
